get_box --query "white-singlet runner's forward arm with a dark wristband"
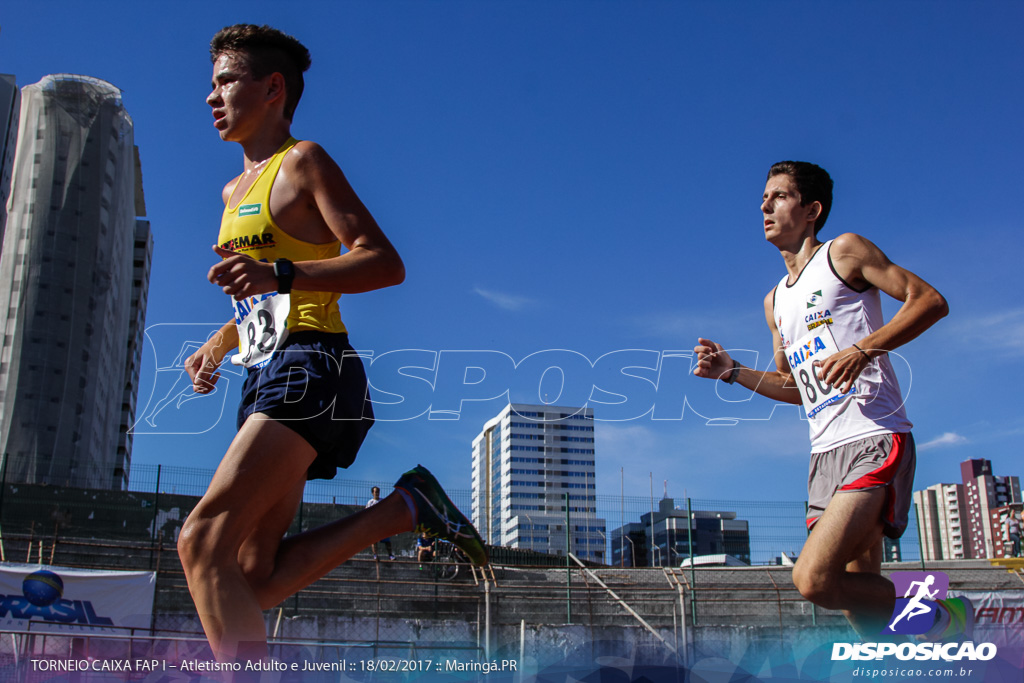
[693,290,801,405]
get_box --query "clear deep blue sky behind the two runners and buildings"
[0,0,1024,501]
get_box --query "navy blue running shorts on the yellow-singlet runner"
[238,330,374,479]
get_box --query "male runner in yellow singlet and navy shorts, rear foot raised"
[178,25,487,661]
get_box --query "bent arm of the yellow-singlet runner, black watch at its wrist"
[208,141,406,299]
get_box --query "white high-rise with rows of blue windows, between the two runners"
[472,403,606,562]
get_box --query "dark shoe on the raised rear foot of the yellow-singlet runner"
[394,465,487,567]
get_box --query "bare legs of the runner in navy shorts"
[178,414,413,660]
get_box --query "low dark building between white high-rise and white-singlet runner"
[609,498,751,567]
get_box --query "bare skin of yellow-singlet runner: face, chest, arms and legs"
[178,45,413,661]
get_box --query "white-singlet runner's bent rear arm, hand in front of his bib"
[818,232,949,392]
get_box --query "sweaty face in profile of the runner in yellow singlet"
[206,53,265,141]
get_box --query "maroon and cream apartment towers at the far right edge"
[913,459,1021,560]
